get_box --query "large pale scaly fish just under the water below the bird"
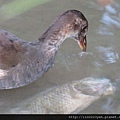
[27,77,115,114]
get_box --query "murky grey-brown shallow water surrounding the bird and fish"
[0,0,120,113]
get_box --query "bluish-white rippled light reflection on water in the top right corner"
[98,2,120,35]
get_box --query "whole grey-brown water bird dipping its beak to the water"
[0,9,88,90]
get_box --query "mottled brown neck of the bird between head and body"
[39,23,69,49]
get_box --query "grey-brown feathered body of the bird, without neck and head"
[0,31,57,89]
